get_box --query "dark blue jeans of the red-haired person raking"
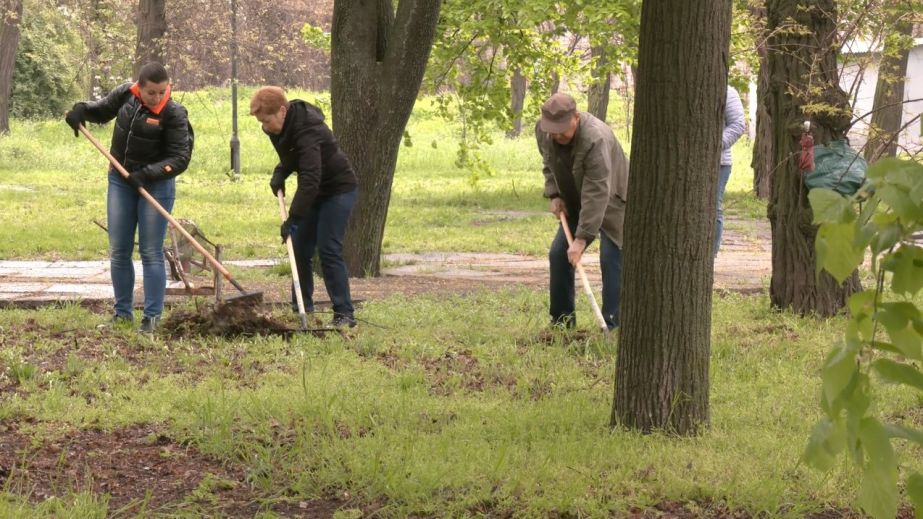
[292,191,359,317]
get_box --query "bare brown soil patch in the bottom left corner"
[0,422,362,517]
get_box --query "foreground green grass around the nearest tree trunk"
[0,290,921,517]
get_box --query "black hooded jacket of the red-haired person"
[267,99,359,220]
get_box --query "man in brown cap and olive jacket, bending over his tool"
[535,93,628,330]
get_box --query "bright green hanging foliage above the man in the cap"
[424,0,640,179]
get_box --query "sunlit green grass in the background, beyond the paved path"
[0,89,765,259]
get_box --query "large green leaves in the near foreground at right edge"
[805,158,923,519]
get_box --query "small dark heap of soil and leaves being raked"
[160,304,296,339]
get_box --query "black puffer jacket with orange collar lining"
[83,83,193,182]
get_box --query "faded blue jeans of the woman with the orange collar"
[106,170,176,319]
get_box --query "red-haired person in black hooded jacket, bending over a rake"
[250,86,359,328]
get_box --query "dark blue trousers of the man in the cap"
[548,218,622,330]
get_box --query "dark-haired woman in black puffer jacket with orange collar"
[65,63,193,333]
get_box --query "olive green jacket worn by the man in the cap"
[535,112,628,247]
